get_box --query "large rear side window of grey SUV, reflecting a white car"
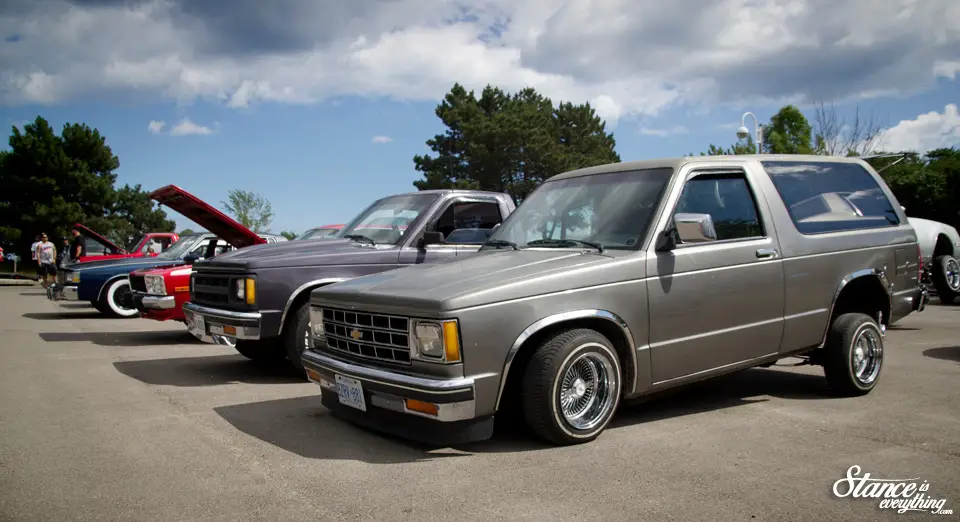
[762,161,900,234]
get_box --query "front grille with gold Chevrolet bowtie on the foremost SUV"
[323,308,410,364]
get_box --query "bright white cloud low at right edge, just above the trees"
[876,103,960,154]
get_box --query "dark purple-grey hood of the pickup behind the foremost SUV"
[194,239,399,270]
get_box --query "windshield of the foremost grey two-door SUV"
[488,168,673,250]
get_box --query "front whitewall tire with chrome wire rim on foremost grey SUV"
[522,328,621,446]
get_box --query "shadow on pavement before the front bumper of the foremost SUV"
[214,389,467,464]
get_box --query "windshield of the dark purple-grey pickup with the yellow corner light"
[332,194,438,245]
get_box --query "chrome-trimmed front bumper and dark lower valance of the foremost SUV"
[301,350,493,445]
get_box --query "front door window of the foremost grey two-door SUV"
[674,174,764,241]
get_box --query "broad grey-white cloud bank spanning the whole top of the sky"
[0,0,960,126]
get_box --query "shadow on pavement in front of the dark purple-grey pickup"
[113,352,307,387]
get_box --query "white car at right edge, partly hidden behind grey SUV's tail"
[908,218,960,304]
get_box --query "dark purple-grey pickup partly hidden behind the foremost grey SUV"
[183,190,515,372]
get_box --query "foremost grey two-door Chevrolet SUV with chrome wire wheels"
[302,155,926,445]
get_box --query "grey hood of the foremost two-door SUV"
[312,250,624,310]
